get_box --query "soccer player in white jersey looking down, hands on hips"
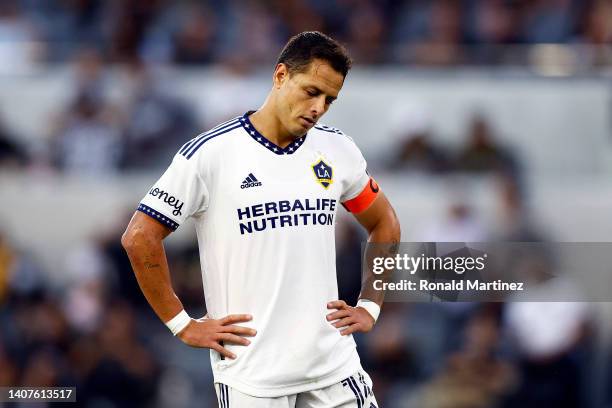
[122,32,400,408]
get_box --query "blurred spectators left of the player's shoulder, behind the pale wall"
[0,53,203,175]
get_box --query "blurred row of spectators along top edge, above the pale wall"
[0,0,612,67]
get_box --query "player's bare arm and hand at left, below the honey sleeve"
[121,212,256,358]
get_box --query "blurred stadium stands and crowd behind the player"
[0,0,612,408]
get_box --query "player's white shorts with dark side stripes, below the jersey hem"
[215,370,378,408]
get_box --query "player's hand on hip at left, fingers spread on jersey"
[177,314,257,359]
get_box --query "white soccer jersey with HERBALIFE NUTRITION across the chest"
[138,112,378,397]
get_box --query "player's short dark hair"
[276,31,353,77]
